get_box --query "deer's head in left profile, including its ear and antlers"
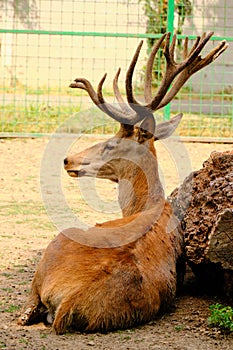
[64,33,228,214]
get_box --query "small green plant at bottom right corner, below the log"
[208,303,233,332]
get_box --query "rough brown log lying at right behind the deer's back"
[169,151,233,299]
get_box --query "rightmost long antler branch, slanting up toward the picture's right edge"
[157,40,229,109]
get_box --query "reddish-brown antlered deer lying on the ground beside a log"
[18,33,228,334]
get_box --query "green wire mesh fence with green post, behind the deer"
[0,0,233,141]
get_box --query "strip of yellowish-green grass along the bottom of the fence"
[0,98,233,137]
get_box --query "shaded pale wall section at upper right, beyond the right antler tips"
[183,0,233,92]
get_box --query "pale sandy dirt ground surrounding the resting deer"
[0,137,233,350]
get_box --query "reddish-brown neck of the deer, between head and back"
[118,150,164,217]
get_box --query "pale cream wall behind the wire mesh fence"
[0,0,233,89]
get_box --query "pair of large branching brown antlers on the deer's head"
[70,32,228,125]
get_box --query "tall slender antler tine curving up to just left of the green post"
[144,33,166,103]
